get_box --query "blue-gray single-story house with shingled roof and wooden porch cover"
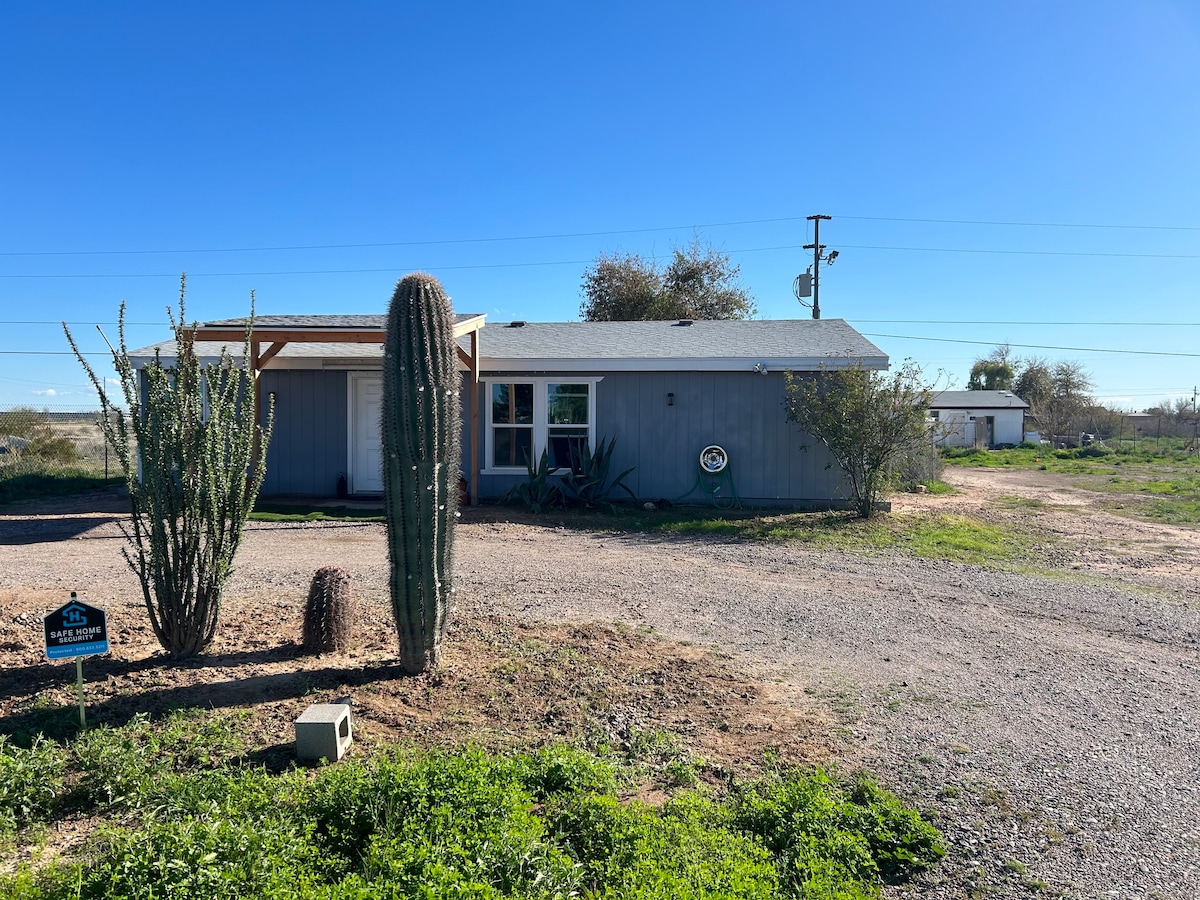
[131,314,888,506]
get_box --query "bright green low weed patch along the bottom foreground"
[0,714,944,900]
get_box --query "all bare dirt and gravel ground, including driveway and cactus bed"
[0,468,1200,900]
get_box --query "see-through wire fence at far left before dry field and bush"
[0,406,121,485]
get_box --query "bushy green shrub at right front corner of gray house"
[785,362,934,518]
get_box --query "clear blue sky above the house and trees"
[0,0,1200,408]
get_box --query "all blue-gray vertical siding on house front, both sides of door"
[262,370,847,506]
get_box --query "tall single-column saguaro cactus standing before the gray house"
[380,272,460,674]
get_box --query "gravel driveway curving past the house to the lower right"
[0,475,1200,900]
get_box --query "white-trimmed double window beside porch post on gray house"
[484,376,600,472]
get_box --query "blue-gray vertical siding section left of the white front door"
[260,368,349,497]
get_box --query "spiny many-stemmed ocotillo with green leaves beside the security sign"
[62,282,274,659]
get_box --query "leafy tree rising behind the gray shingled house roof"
[580,239,757,322]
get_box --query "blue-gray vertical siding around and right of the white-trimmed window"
[464,372,848,506]
